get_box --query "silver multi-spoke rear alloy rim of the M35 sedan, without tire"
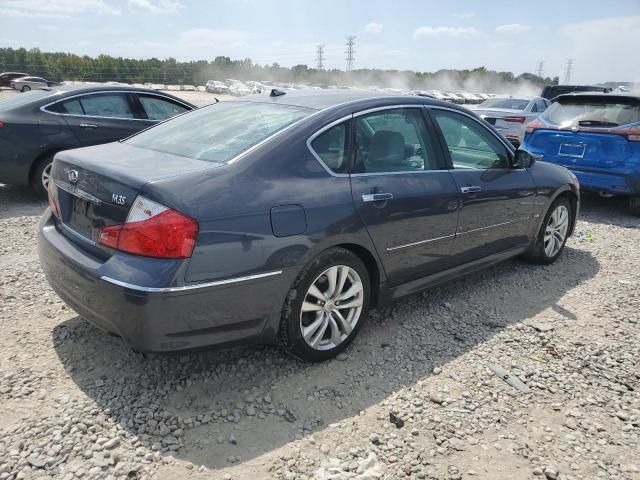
[300,265,364,350]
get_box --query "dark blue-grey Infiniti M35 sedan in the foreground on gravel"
[39,91,579,361]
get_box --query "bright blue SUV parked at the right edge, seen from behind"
[522,93,640,216]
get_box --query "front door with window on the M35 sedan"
[429,108,535,264]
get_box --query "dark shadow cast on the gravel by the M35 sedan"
[52,248,599,468]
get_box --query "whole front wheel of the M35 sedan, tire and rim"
[524,196,573,265]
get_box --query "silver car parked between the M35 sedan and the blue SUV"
[472,96,551,148]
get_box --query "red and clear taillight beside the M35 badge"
[98,196,198,258]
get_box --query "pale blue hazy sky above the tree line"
[0,0,640,83]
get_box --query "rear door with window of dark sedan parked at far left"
[55,92,150,146]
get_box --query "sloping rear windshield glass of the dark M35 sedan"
[126,102,315,163]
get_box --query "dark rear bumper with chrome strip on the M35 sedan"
[38,209,290,352]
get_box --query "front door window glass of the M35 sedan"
[432,109,509,169]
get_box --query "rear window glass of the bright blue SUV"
[543,97,640,127]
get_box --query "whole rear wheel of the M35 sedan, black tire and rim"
[279,248,371,362]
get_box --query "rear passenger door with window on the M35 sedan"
[351,107,458,286]
